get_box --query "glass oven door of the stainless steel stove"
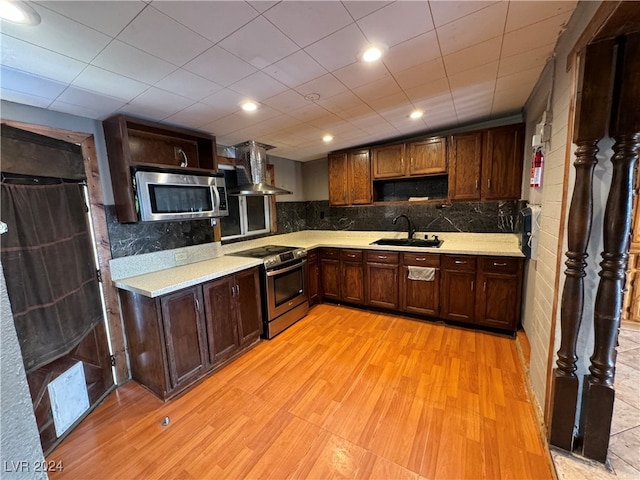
[266,260,307,320]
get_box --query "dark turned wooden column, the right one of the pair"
[581,34,640,462]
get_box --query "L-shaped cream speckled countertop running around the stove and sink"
[111,230,523,297]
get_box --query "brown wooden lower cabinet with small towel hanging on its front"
[400,252,440,317]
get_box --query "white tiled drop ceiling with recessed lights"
[1,0,576,161]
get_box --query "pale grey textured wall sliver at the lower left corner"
[0,264,47,479]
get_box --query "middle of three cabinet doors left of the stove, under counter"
[202,277,239,364]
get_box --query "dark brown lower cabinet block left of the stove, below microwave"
[119,268,262,400]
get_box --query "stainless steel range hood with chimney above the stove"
[227,140,293,195]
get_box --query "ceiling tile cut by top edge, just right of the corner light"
[35,0,147,37]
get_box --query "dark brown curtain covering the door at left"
[0,183,102,372]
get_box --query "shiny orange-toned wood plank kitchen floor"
[48,304,553,479]
